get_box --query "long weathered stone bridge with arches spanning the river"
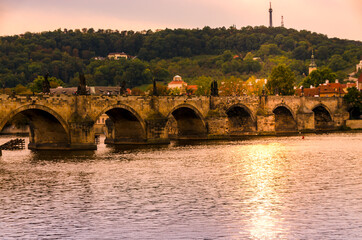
[0,95,349,150]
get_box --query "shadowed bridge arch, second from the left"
[96,104,147,144]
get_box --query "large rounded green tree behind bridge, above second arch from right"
[266,64,295,95]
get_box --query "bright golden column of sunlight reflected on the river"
[243,143,287,239]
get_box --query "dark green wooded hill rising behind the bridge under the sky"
[0,26,362,91]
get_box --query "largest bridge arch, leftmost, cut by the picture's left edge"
[0,104,70,149]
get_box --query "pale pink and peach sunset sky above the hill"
[0,0,362,41]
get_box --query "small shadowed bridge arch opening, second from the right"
[273,104,298,132]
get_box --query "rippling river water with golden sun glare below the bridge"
[0,133,362,239]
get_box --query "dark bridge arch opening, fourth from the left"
[226,104,256,134]
